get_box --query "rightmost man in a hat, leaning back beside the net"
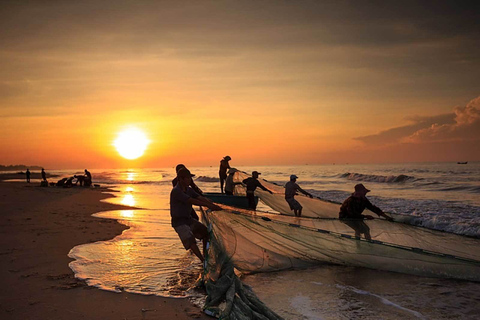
[339,183,393,240]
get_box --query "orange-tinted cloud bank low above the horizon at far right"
[354,97,480,146]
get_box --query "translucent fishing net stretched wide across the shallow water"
[202,172,480,281]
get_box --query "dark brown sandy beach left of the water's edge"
[0,179,211,320]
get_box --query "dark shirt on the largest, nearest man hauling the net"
[170,185,199,228]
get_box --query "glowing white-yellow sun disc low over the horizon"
[113,128,150,160]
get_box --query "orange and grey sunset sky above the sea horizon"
[0,0,480,169]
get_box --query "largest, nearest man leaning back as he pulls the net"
[170,168,222,262]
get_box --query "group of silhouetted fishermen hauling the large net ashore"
[170,156,393,262]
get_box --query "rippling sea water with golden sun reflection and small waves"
[63,162,480,319]
